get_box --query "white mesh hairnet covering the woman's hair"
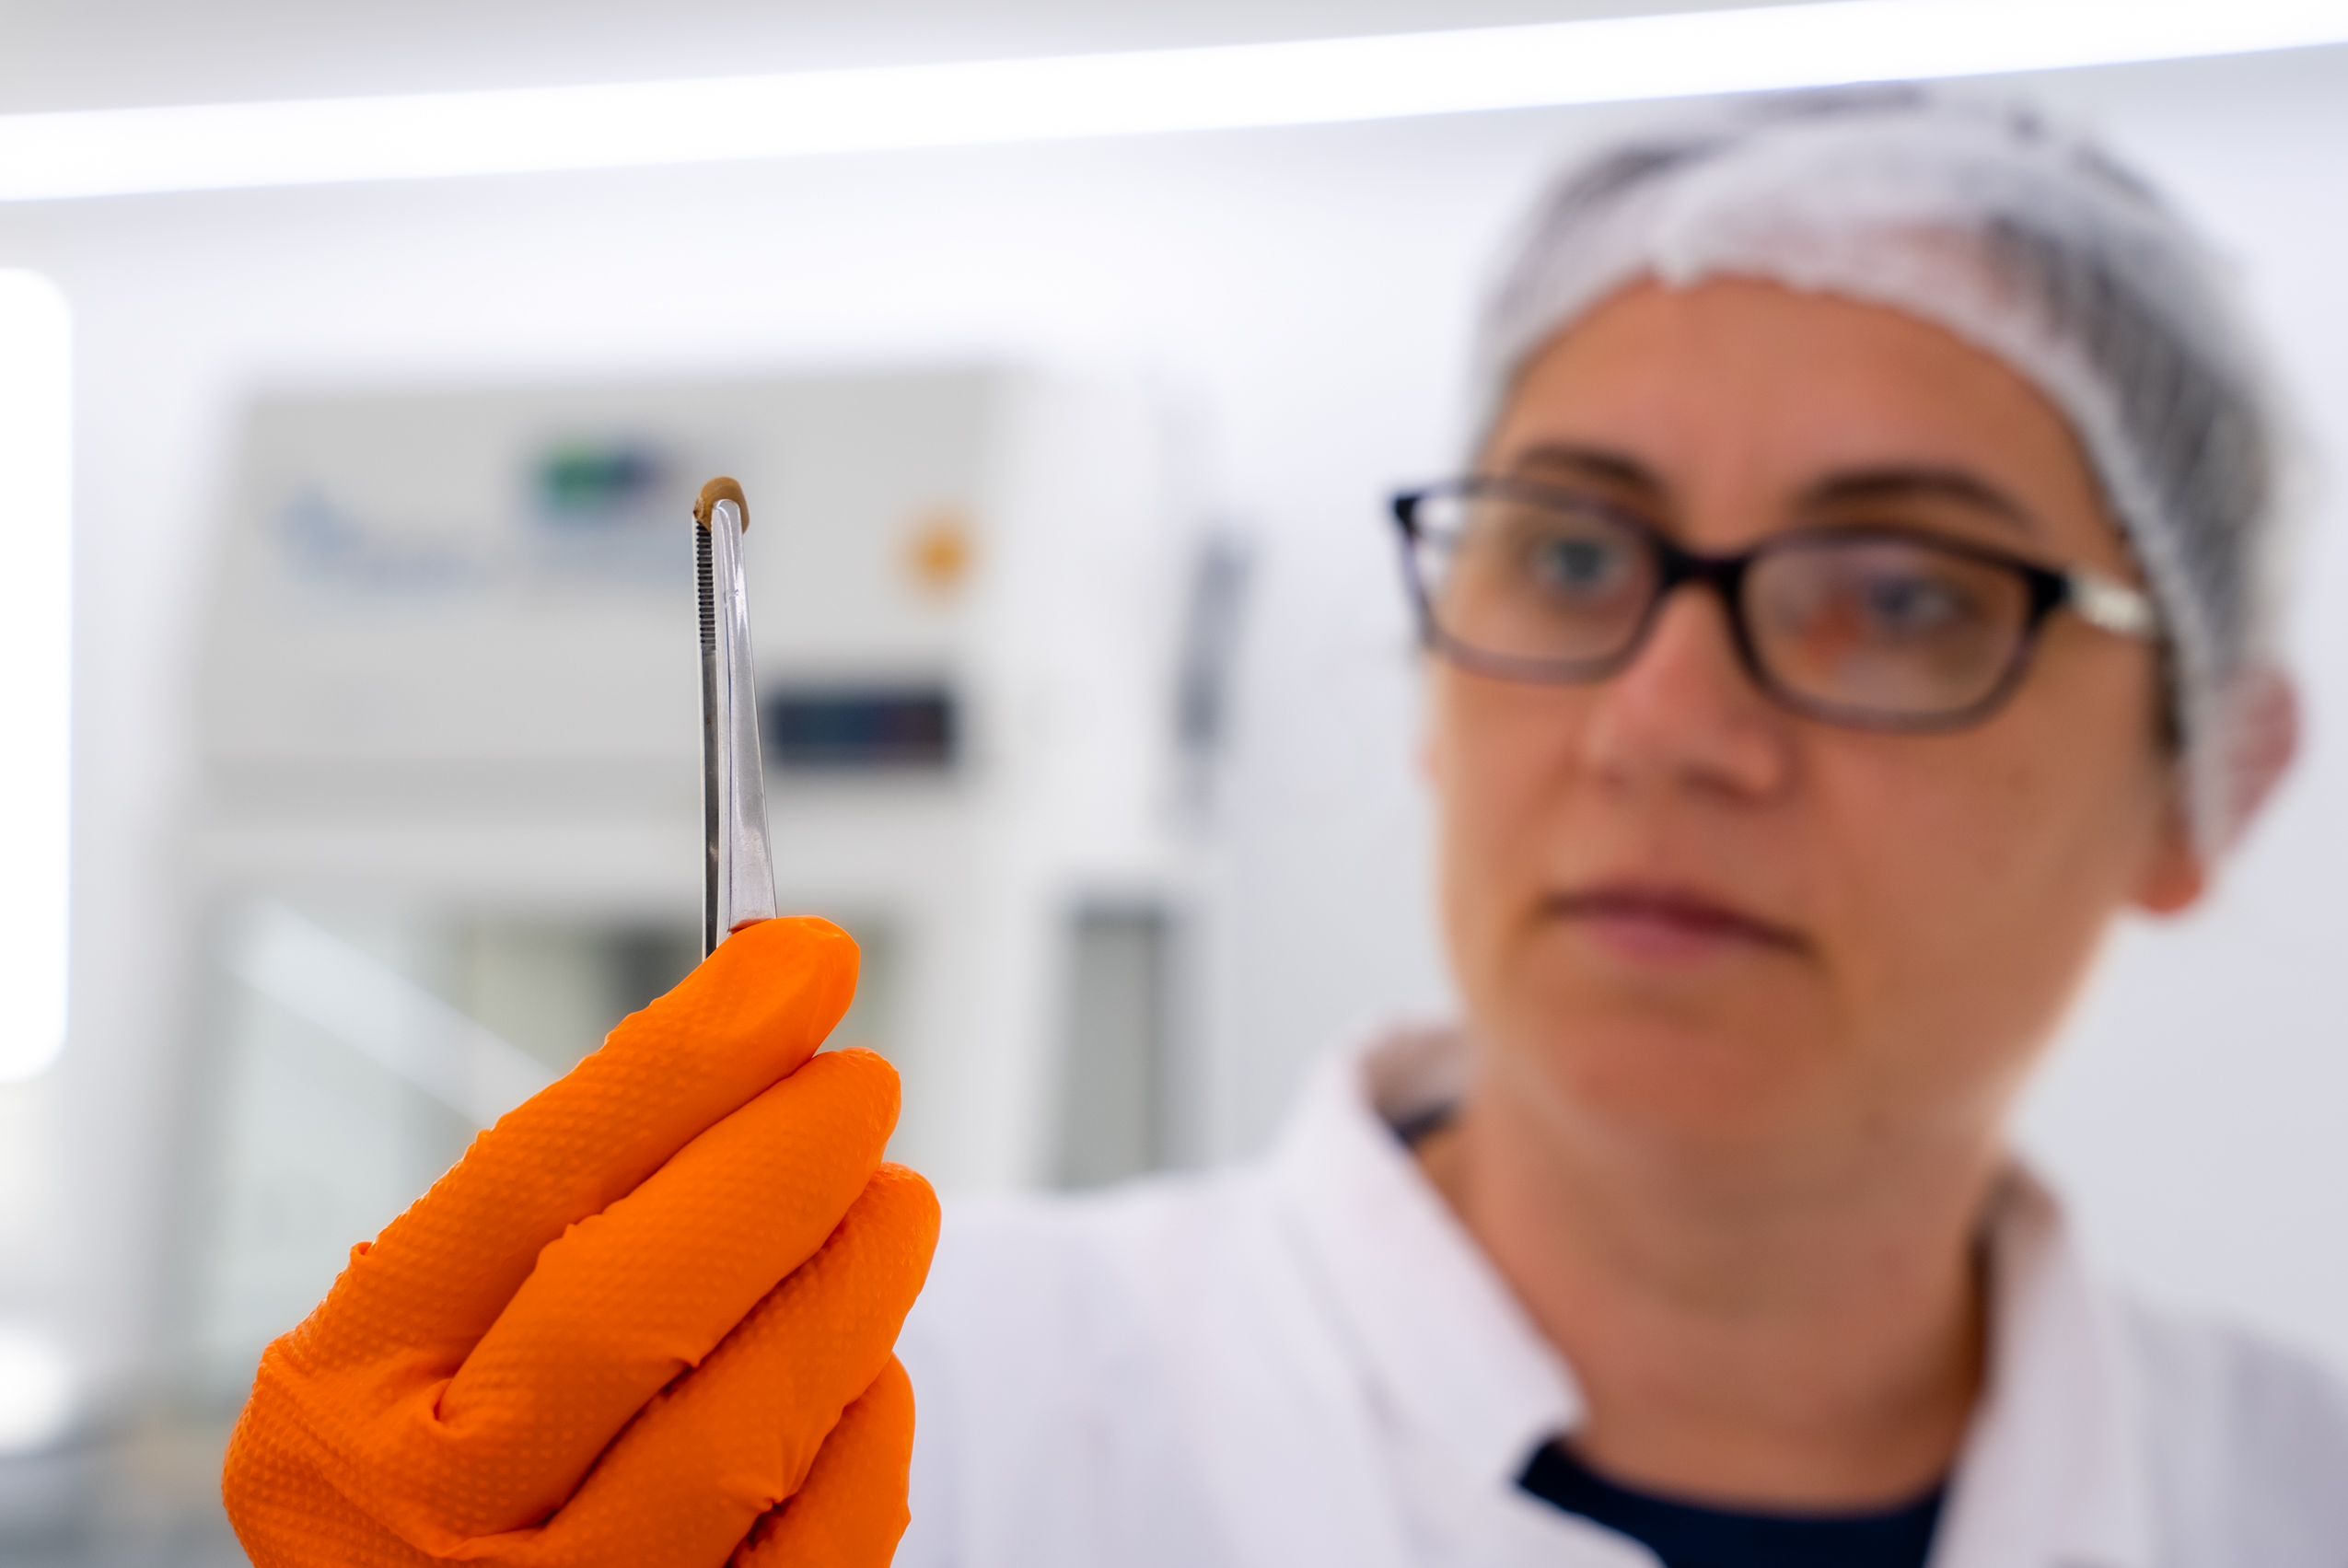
[1480,87,2278,854]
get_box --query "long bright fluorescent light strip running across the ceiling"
[0,0,2348,202]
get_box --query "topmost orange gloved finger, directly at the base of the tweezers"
[308,920,857,1373]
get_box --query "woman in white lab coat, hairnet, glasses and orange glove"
[227,91,2348,1568]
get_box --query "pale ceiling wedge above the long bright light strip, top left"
[0,0,1794,112]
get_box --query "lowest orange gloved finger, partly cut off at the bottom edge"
[733,1357,913,1568]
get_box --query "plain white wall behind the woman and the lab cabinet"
[0,40,2348,1399]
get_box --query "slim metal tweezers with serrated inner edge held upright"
[692,479,775,958]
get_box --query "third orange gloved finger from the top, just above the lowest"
[517,1165,936,1568]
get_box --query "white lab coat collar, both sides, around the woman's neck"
[1271,1030,2153,1568]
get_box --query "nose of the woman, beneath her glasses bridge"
[1583,585,1796,798]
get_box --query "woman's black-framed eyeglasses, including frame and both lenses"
[1395,477,2160,732]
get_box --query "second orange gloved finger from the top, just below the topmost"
[413,1051,897,1538]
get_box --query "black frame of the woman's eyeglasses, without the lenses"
[1390,474,2160,735]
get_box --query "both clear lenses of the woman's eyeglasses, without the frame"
[1416,493,2031,723]
